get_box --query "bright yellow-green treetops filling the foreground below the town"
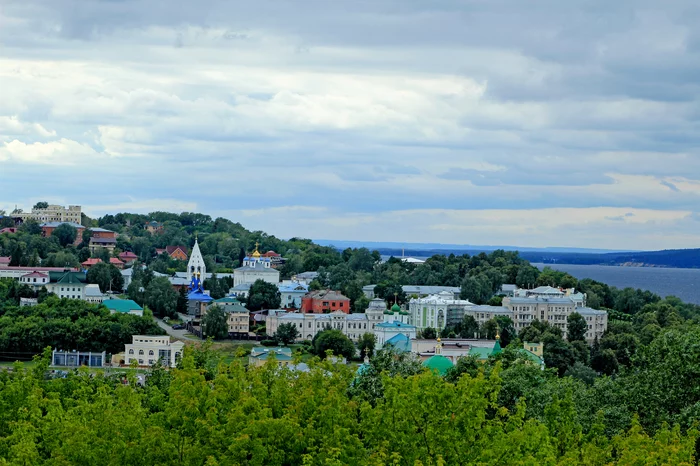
[0,351,698,466]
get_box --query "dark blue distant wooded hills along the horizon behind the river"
[314,240,700,268]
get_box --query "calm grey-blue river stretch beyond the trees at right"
[532,263,700,304]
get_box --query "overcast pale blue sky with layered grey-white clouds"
[0,0,700,250]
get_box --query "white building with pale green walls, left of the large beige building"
[408,291,474,331]
